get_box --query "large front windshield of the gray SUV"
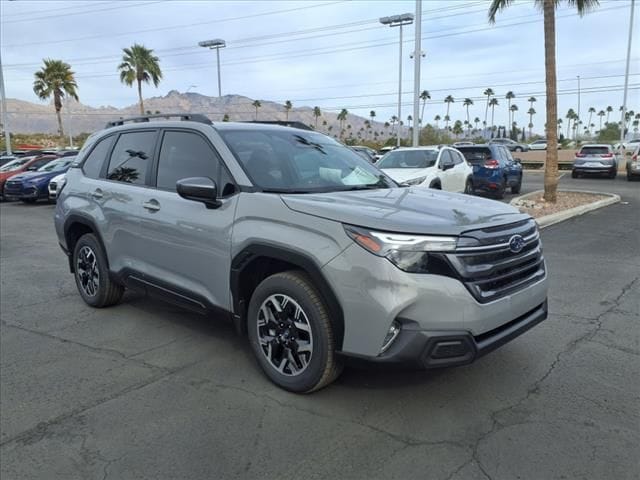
[219,129,396,193]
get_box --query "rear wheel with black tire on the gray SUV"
[73,233,124,308]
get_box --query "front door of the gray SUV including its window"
[140,129,238,309]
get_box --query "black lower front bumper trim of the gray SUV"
[343,300,548,369]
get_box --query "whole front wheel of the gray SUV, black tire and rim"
[247,271,342,393]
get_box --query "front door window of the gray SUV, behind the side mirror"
[157,132,220,191]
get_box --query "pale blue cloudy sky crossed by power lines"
[0,0,640,129]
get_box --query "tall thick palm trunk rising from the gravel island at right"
[543,2,558,203]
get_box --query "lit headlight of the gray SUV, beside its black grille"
[344,225,458,273]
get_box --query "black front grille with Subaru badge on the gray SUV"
[447,220,545,303]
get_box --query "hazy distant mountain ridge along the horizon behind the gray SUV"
[7,90,400,139]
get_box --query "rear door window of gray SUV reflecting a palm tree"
[107,131,157,185]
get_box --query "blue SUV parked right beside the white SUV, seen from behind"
[458,144,522,198]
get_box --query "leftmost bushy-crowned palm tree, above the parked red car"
[33,58,78,137]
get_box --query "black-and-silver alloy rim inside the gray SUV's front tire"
[256,294,313,377]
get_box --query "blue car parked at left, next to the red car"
[4,156,76,203]
